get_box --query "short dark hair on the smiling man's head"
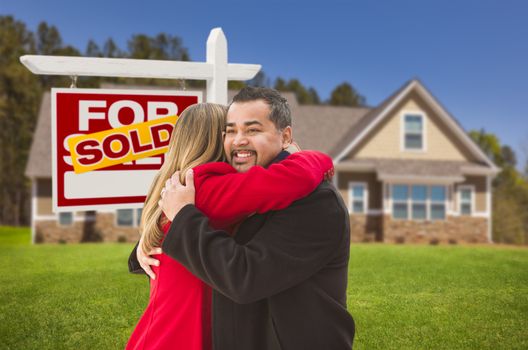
[231,86,291,131]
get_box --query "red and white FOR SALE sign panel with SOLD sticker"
[52,89,202,211]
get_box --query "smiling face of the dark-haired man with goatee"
[224,100,291,172]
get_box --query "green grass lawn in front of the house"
[0,227,528,349]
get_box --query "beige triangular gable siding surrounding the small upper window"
[349,93,474,161]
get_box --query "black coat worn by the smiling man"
[155,182,354,350]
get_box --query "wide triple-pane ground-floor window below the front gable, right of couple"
[391,185,447,220]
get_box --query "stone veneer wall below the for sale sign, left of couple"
[35,213,139,243]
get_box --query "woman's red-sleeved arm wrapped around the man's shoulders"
[194,151,333,228]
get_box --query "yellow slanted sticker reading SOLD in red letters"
[68,116,178,174]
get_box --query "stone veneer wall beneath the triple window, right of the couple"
[383,215,488,243]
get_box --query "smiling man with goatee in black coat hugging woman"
[132,87,354,350]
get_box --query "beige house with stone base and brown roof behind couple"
[26,80,499,243]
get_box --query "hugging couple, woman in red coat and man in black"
[127,87,354,350]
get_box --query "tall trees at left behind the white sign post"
[0,16,194,226]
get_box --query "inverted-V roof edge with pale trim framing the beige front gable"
[334,79,500,172]
